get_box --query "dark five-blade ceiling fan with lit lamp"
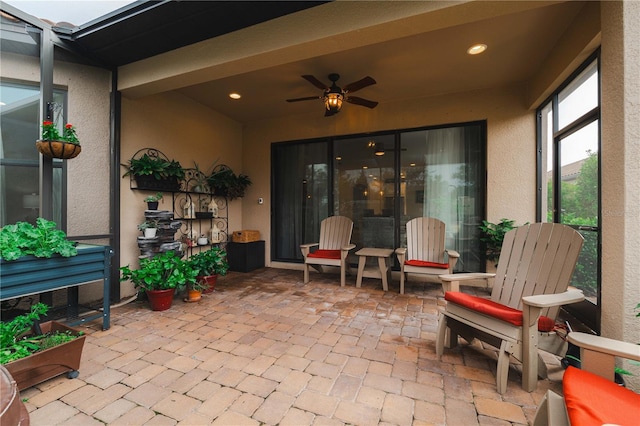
[287,73,378,117]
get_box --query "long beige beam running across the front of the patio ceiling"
[118,1,562,98]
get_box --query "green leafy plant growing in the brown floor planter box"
[0,303,78,364]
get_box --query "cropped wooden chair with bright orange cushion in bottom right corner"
[533,333,640,426]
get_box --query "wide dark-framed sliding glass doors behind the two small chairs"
[272,122,486,271]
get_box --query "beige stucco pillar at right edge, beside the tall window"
[601,1,640,389]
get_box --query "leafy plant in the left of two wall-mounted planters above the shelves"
[122,148,185,191]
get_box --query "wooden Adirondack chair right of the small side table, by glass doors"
[396,217,460,294]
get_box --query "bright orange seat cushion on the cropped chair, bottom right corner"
[562,366,640,426]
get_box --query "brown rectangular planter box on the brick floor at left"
[5,321,86,390]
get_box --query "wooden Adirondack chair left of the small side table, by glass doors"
[300,216,356,287]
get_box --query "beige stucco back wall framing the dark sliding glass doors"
[243,86,536,268]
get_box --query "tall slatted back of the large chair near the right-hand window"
[491,223,584,318]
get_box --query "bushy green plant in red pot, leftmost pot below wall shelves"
[120,251,197,311]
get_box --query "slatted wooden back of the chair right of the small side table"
[407,217,445,263]
